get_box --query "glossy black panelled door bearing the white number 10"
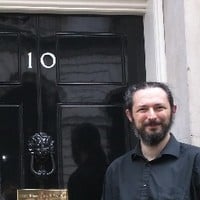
[0,14,145,199]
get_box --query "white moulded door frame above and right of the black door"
[0,0,167,82]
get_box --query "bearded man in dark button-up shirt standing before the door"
[102,82,200,200]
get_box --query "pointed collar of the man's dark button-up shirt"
[132,134,180,160]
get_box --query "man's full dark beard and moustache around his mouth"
[133,114,173,146]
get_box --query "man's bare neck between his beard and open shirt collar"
[141,133,170,161]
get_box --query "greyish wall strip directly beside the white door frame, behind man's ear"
[164,0,191,143]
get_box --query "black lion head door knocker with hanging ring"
[28,132,55,176]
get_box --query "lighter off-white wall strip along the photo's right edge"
[184,0,200,146]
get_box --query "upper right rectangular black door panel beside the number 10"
[57,34,124,84]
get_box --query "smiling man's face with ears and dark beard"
[126,88,176,146]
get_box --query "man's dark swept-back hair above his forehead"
[124,82,174,110]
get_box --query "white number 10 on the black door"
[28,52,56,69]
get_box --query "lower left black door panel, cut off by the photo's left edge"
[0,105,23,199]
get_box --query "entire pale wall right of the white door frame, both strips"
[163,0,200,146]
